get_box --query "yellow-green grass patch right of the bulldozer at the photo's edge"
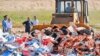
[89,11,100,31]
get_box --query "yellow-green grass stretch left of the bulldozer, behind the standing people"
[0,10,53,27]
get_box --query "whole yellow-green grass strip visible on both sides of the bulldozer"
[0,10,100,27]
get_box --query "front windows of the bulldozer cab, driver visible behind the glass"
[58,1,81,13]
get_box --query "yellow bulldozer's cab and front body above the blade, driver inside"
[51,0,88,24]
